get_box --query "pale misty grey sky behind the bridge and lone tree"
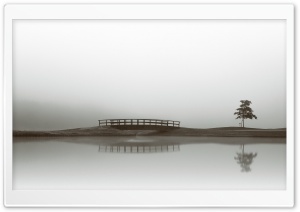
[13,20,286,130]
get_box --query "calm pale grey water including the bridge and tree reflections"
[13,137,286,189]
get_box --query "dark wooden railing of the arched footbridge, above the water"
[98,119,180,127]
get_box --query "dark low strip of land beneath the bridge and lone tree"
[13,127,286,138]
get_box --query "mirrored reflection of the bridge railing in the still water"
[98,144,180,153]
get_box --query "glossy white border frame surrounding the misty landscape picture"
[4,4,294,207]
